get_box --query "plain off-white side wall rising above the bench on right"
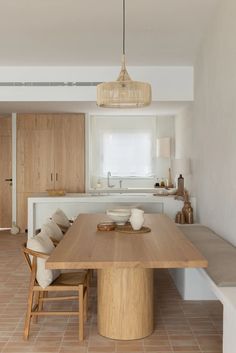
[193,0,236,245]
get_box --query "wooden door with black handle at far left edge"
[0,116,12,228]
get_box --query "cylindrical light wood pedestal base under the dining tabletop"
[98,267,153,340]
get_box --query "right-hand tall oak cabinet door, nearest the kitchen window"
[54,114,85,192]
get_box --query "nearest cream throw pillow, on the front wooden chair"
[27,232,60,288]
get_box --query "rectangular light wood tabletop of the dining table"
[46,214,207,269]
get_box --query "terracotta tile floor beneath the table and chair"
[0,232,222,353]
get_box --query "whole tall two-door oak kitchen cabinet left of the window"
[17,114,85,230]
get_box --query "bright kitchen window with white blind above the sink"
[91,116,156,178]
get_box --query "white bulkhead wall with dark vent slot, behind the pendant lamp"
[0,66,193,102]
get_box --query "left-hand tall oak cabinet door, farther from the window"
[17,114,54,192]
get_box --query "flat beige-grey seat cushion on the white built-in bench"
[179,225,236,287]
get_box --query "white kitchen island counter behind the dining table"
[28,192,196,237]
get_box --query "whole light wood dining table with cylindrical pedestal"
[46,214,208,340]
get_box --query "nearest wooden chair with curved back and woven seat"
[22,244,88,341]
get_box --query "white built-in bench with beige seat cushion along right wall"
[170,224,236,353]
